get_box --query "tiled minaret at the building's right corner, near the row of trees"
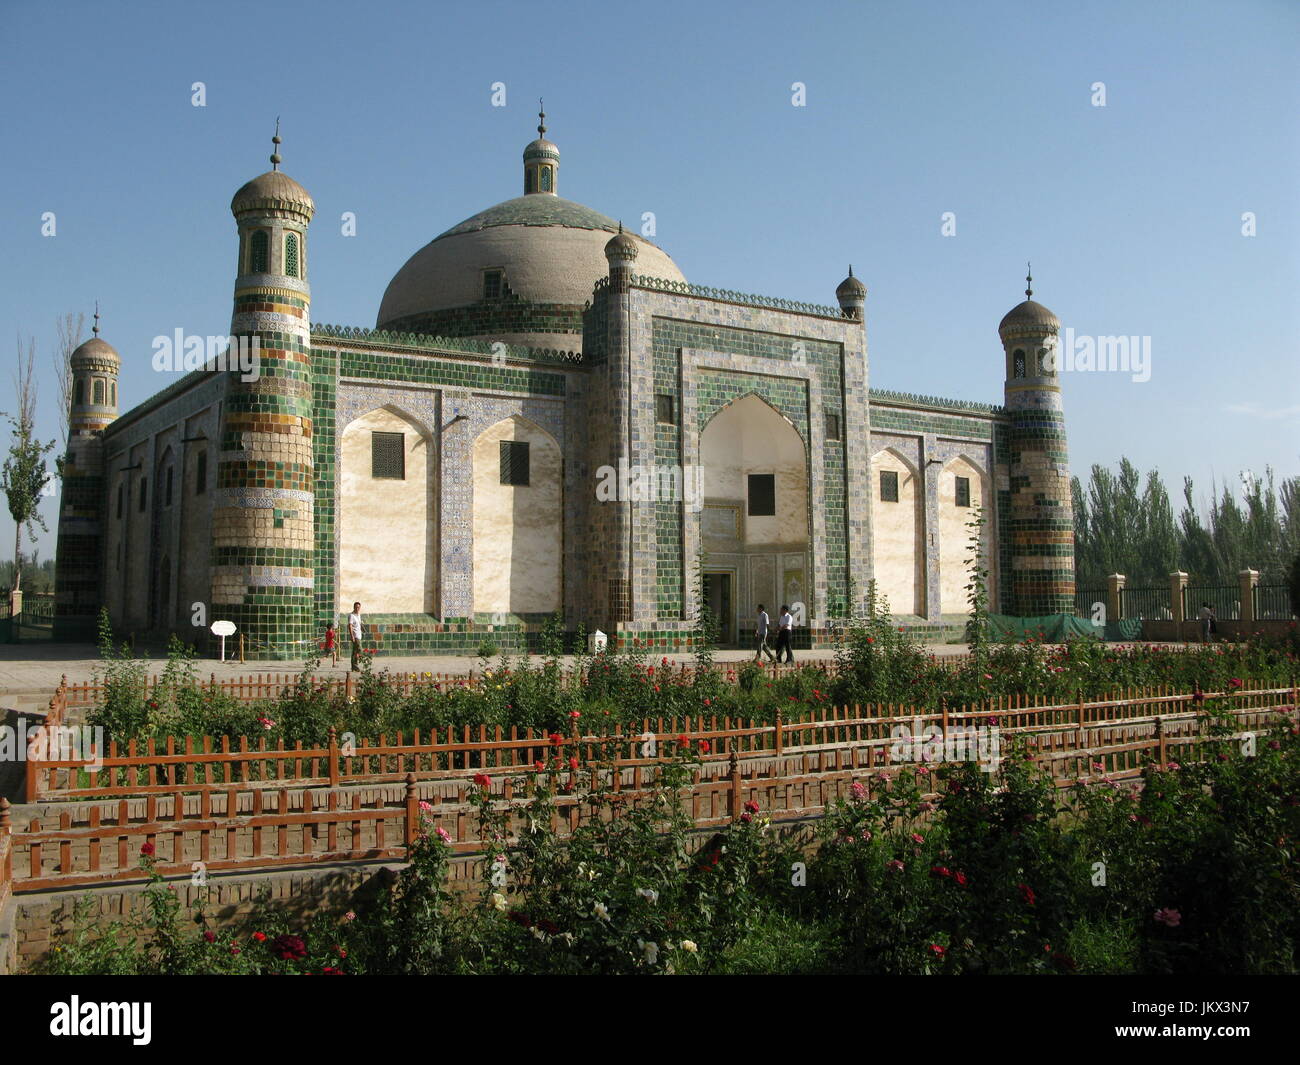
[997,266,1074,618]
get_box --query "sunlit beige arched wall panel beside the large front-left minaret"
[337,408,437,614]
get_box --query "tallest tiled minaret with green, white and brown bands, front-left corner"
[211,122,316,658]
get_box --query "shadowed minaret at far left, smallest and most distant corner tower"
[55,307,122,640]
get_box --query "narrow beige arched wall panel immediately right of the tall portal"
[871,450,926,616]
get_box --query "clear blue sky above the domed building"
[0,0,1300,557]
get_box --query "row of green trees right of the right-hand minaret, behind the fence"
[1073,459,1300,588]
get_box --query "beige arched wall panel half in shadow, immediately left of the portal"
[473,416,564,614]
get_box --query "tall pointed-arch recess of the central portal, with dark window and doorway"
[699,394,814,642]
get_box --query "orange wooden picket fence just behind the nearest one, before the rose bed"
[25,687,1297,802]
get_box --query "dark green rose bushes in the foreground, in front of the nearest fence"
[38,722,1300,975]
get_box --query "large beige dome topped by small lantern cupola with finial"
[376,116,686,350]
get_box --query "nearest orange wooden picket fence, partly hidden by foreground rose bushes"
[0,689,1296,902]
